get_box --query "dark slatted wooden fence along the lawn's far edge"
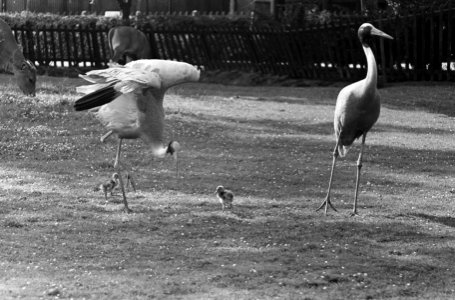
[9,9,455,81]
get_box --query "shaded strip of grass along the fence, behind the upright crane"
[175,82,455,116]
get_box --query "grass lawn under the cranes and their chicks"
[0,75,455,300]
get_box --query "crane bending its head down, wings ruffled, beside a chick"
[74,59,200,212]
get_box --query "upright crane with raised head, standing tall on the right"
[317,23,393,215]
